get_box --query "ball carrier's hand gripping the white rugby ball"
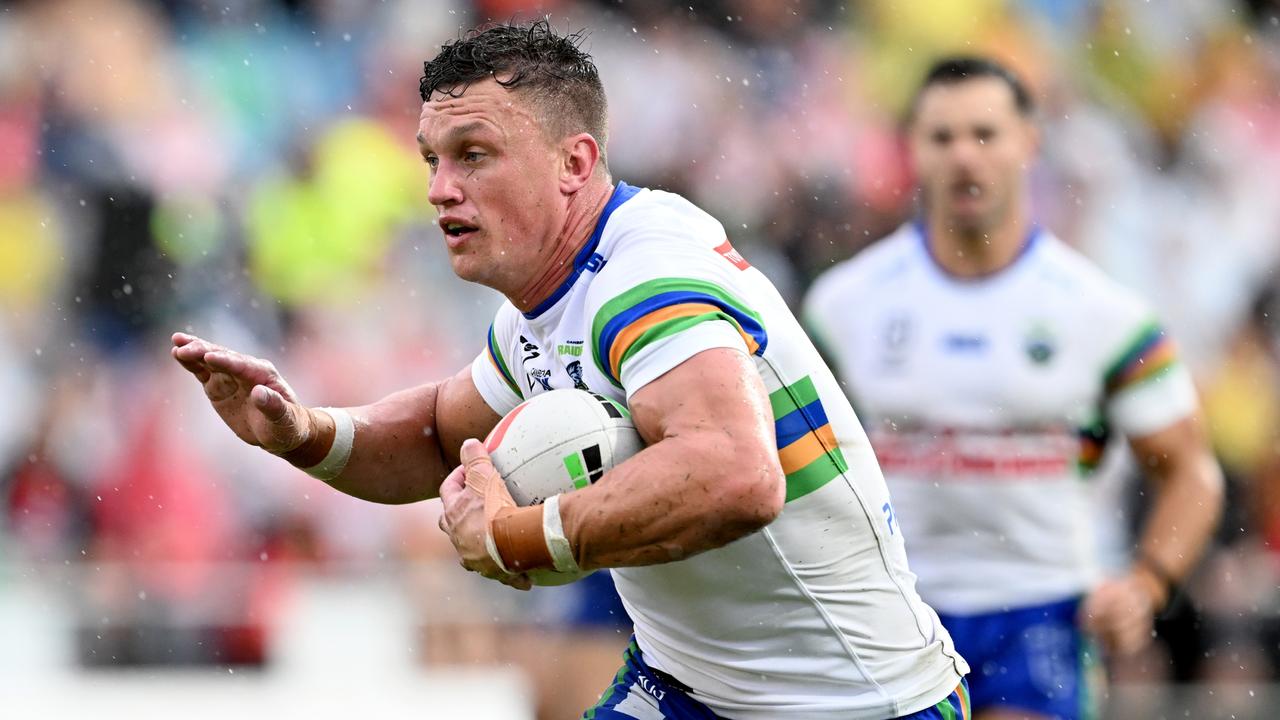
[440,439,532,591]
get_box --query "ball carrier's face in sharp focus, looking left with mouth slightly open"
[417,79,566,291]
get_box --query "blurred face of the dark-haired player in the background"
[910,77,1037,233]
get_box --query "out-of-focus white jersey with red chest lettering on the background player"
[805,224,1196,614]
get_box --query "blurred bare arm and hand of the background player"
[1084,414,1222,655]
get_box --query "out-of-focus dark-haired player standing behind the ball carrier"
[805,58,1221,720]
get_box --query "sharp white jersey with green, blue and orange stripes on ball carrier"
[472,183,968,720]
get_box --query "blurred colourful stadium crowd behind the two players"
[0,0,1280,719]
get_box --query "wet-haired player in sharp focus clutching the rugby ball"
[173,23,966,719]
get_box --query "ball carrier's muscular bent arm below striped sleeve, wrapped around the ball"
[561,348,786,569]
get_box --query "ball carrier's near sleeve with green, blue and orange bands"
[591,278,768,396]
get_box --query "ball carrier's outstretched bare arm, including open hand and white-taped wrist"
[172,333,499,503]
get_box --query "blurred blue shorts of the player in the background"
[938,597,1098,720]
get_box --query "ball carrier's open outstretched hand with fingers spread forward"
[170,333,315,454]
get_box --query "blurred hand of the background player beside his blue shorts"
[1079,569,1165,657]
